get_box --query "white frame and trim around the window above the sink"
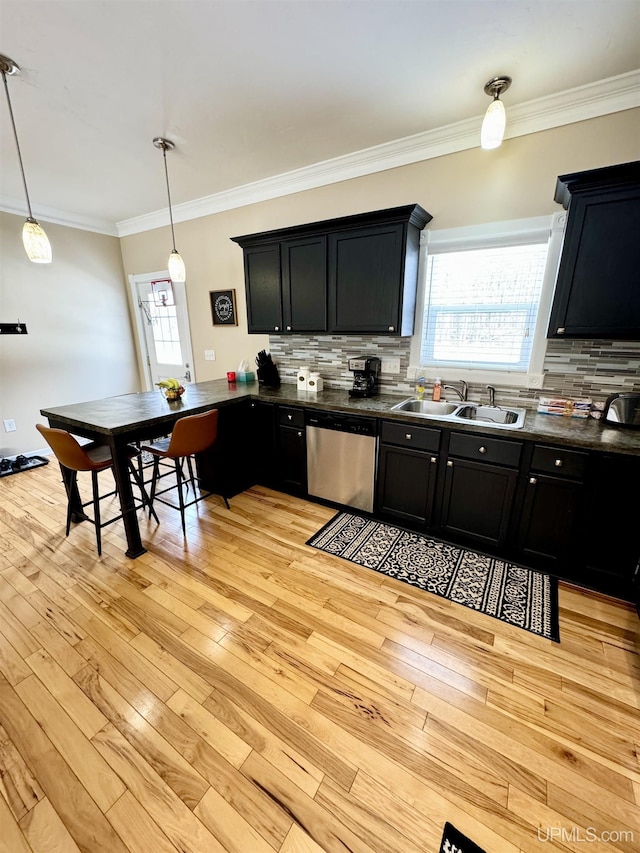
[407,211,567,388]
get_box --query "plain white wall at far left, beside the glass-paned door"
[0,213,140,456]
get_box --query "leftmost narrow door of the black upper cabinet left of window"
[244,243,282,333]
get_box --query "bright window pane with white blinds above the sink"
[420,241,548,372]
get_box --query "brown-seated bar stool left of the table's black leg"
[36,424,160,556]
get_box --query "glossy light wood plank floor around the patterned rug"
[0,463,640,853]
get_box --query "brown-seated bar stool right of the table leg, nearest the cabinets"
[140,409,230,536]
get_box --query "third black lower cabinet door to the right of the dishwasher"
[516,474,584,568]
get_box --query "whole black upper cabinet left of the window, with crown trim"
[232,204,431,335]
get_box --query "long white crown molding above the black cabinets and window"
[116,69,640,237]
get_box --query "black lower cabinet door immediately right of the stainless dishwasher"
[376,444,438,527]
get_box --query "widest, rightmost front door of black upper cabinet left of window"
[329,223,405,335]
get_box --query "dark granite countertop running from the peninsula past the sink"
[41,379,640,455]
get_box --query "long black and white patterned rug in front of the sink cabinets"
[306,512,560,642]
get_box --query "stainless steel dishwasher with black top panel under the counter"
[305,411,377,512]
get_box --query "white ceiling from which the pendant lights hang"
[0,0,640,233]
